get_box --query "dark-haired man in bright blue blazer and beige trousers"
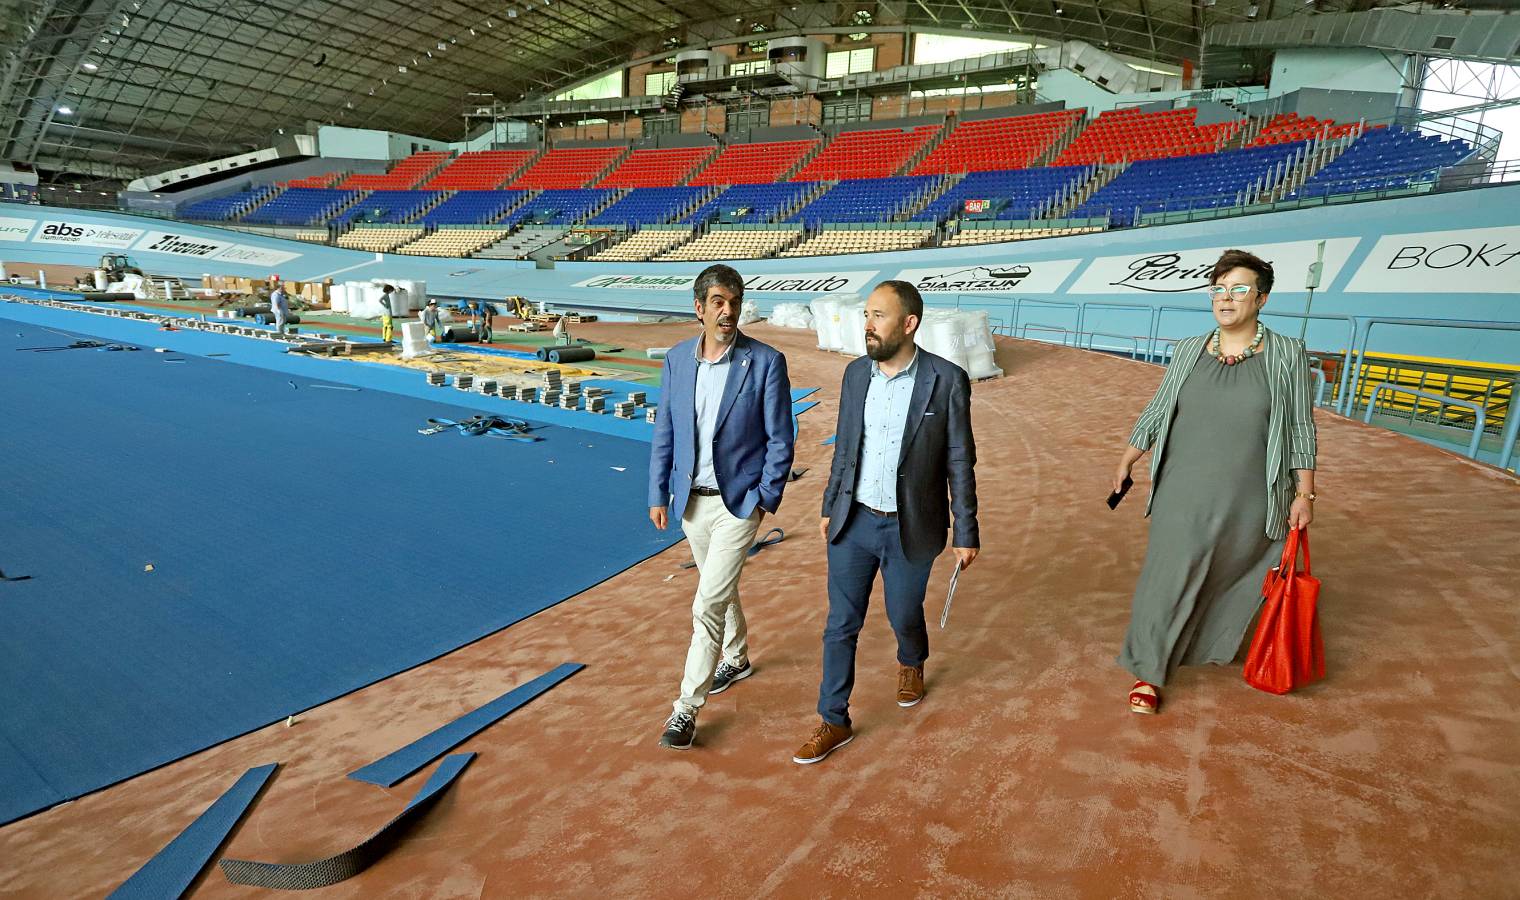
[649,266,795,749]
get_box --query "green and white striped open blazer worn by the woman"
[1129,328,1316,541]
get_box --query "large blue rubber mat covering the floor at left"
[0,319,681,824]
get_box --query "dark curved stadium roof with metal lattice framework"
[0,0,1447,178]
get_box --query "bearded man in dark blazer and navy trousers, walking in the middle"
[792,281,980,765]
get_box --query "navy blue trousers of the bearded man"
[818,508,935,725]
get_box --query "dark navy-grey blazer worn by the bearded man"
[824,347,982,563]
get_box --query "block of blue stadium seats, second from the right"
[1070,141,1307,225]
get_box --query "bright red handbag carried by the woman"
[1245,528,1325,693]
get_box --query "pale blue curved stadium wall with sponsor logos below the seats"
[0,185,1520,365]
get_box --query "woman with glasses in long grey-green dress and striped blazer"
[1114,249,1315,713]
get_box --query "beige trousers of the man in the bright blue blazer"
[675,494,762,715]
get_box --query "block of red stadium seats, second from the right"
[1052,106,1245,166]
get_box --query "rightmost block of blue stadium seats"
[1287,128,1473,199]
